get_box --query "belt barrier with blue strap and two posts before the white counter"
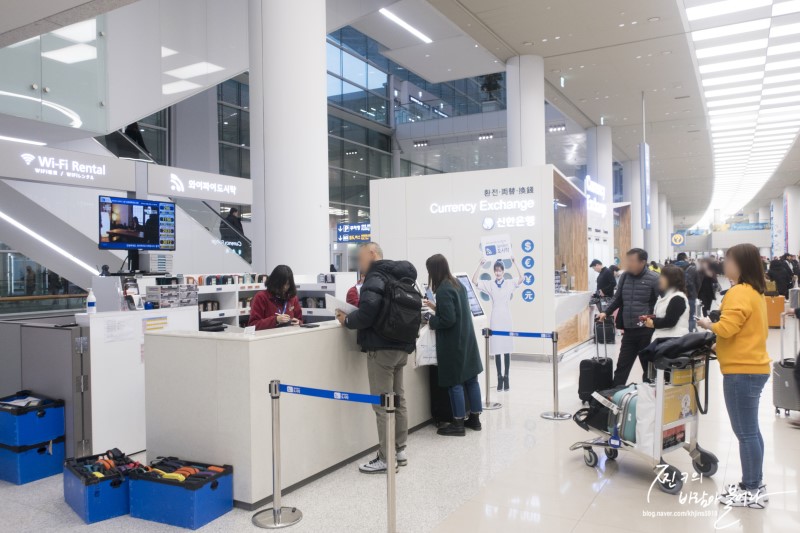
[253,380,397,533]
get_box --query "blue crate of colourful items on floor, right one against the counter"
[129,461,233,529]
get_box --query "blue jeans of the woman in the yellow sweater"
[722,374,769,490]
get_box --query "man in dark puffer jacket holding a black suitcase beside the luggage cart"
[597,248,658,386]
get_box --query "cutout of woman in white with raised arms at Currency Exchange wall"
[472,258,522,391]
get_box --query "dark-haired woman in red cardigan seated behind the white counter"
[247,265,303,330]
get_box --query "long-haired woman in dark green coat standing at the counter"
[425,254,483,437]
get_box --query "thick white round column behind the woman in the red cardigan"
[248,0,330,274]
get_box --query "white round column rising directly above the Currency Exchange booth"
[506,55,545,167]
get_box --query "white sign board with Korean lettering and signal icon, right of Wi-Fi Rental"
[147,165,253,205]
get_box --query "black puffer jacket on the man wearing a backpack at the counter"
[344,259,417,353]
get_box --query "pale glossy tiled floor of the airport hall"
[0,332,800,533]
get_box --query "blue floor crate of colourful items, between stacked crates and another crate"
[64,455,131,524]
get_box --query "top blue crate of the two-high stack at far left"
[0,391,64,446]
